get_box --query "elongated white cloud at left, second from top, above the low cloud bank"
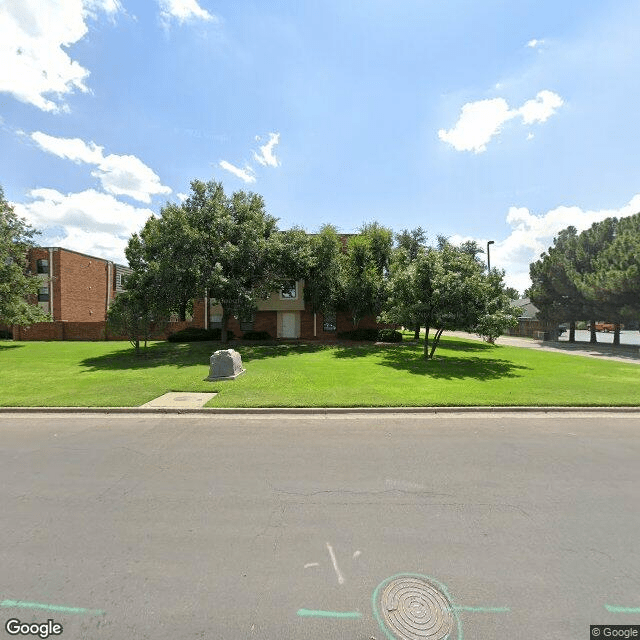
[31,131,171,203]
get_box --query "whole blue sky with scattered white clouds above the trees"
[0,0,640,291]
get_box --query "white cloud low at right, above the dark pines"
[451,194,640,293]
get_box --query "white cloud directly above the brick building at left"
[14,189,153,264]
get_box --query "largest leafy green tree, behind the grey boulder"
[127,180,311,342]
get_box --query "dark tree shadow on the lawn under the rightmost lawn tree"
[380,350,530,380]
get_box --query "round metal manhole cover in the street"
[380,576,454,640]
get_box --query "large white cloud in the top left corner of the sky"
[0,0,121,112]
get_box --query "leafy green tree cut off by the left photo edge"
[0,187,51,326]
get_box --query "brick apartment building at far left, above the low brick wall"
[27,247,131,322]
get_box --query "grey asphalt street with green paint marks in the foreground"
[0,411,640,640]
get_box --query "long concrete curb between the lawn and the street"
[0,406,640,416]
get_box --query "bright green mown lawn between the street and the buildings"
[0,336,640,407]
